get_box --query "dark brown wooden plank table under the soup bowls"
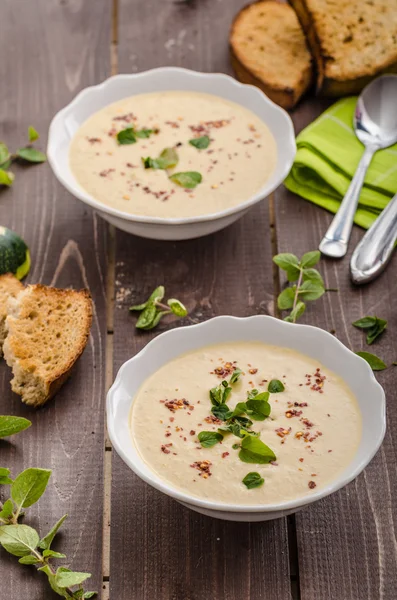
[0,0,397,600]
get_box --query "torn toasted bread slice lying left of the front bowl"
[3,285,92,406]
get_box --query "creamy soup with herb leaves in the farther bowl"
[70,91,277,218]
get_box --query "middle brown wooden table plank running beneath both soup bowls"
[110,0,290,600]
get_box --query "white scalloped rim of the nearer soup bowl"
[106,315,386,513]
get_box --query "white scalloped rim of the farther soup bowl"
[47,67,296,226]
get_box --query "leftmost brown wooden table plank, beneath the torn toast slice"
[0,0,110,600]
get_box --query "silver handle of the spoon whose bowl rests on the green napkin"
[319,146,378,258]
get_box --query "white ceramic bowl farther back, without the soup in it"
[47,67,296,240]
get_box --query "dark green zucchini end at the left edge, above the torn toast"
[0,226,30,279]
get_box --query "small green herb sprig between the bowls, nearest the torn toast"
[130,285,187,330]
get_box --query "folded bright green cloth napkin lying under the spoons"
[284,97,397,229]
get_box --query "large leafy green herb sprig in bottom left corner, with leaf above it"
[0,416,97,599]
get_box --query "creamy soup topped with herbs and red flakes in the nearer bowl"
[130,342,361,504]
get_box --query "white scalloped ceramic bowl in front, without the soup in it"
[107,315,386,521]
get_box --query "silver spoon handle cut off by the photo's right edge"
[350,194,397,284]
